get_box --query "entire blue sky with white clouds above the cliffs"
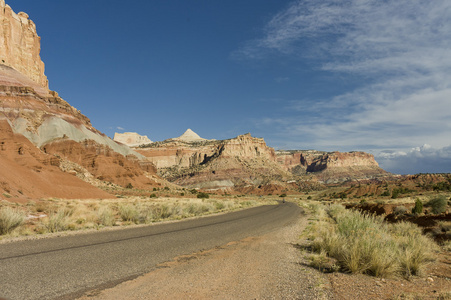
[6,0,451,174]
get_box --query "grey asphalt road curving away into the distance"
[0,202,301,300]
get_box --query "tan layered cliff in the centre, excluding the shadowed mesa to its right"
[136,134,293,191]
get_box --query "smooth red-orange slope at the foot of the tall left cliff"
[0,120,112,200]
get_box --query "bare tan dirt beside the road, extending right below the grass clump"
[79,214,451,300]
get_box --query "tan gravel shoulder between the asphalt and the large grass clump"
[79,212,332,300]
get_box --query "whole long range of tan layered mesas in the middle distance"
[136,134,388,193]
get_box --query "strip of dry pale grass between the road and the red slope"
[0,194,275,240]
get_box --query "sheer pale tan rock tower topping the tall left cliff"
[0,0,48,88]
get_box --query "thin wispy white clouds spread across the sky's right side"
[235,0,451,171]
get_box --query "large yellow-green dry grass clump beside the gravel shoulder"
[304,205,436,277]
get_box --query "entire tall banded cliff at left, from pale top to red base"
[0,0,160,199]
